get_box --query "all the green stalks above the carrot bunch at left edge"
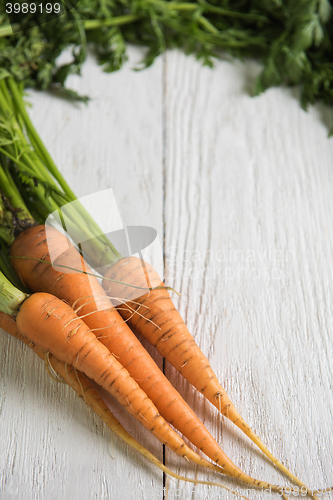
[0,78,121,267]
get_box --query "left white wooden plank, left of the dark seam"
[0,48,163,500]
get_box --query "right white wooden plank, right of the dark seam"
[164,51,333,500]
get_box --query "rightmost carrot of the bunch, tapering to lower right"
[99,257,322,498]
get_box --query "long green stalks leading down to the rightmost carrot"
[0,78,121,266]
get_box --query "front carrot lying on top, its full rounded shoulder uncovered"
[16,292,286,491]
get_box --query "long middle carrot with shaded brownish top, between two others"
[11,226,286,492]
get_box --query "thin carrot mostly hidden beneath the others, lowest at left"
[0,311,252,500]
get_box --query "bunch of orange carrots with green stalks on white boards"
[0,79,329,499]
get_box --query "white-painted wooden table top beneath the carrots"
[0,48,333,500]
